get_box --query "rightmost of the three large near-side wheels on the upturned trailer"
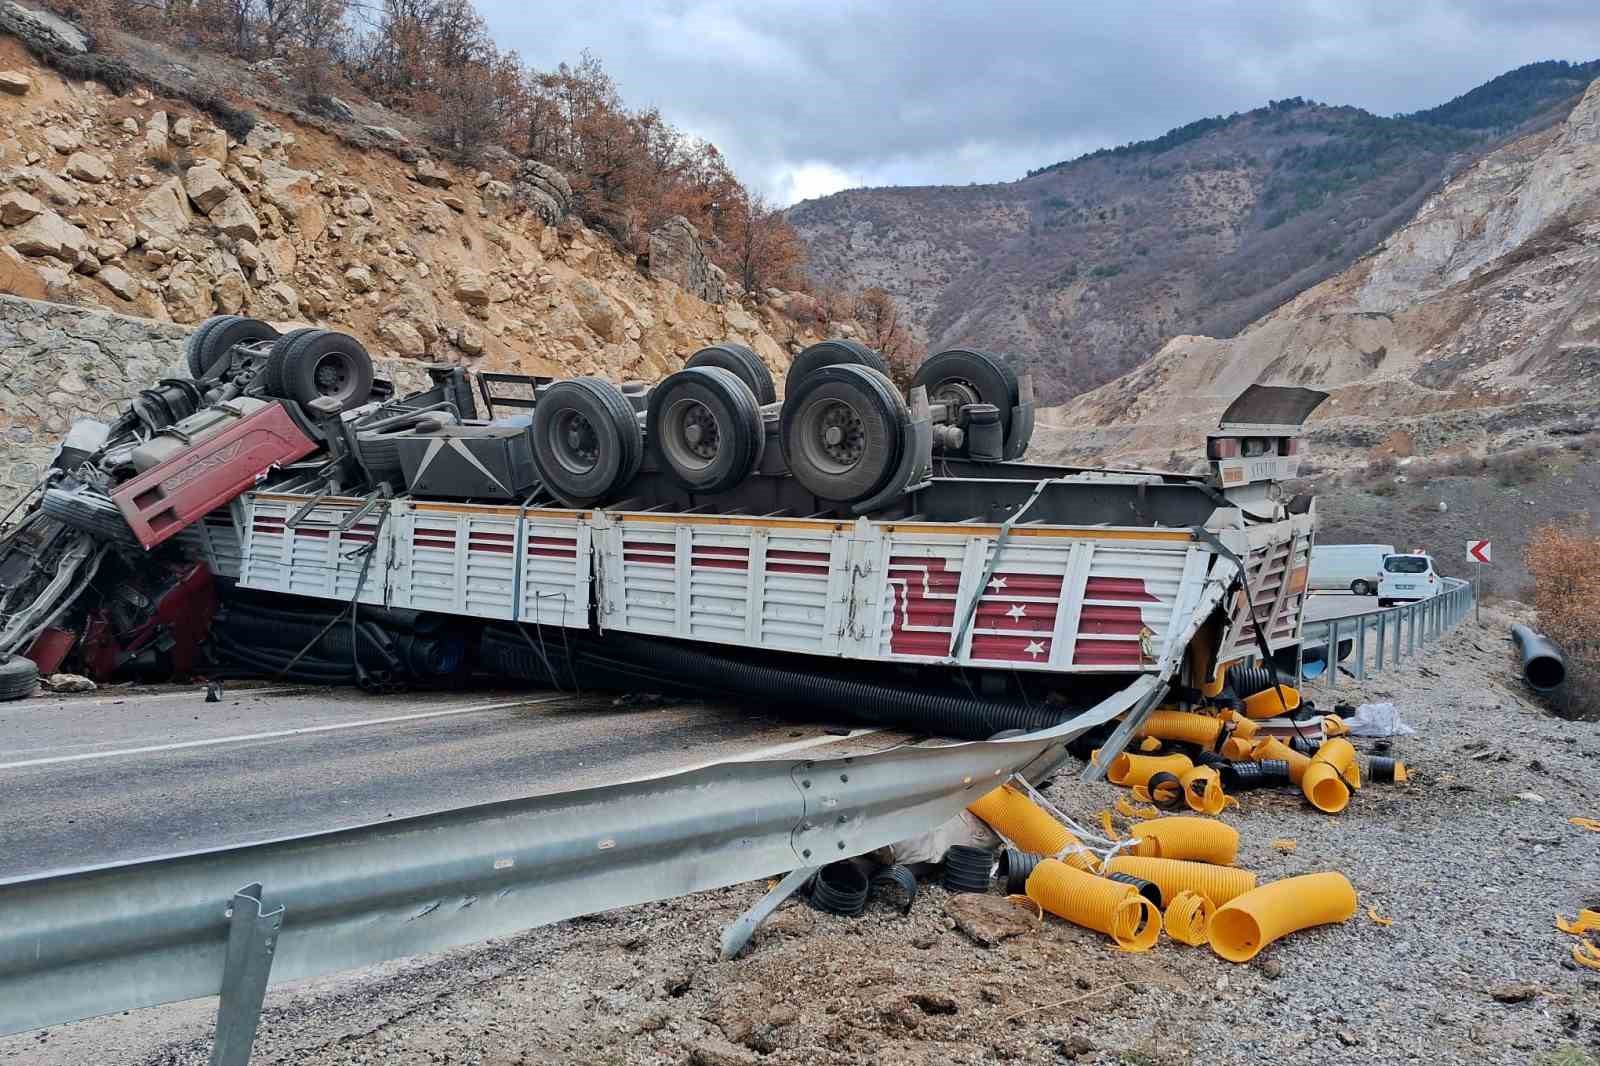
[781,363,910,503]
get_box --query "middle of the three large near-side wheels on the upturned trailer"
[645,367,771,493]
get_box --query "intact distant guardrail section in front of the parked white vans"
[1294,578,1474,688]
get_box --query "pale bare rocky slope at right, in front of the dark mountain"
[1035,80,1600,466]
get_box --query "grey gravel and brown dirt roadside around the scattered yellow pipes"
[18,601,1600,1066]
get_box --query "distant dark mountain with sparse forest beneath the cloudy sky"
[790,62,1600,402]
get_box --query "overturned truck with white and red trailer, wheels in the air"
[0,317,1322,736]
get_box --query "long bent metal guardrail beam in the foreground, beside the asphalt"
[0,674,1163,1034]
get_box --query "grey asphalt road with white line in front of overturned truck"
[0,675,891,879]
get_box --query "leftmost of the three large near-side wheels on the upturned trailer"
[531,378,645,507]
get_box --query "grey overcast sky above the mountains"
[478,0,1600,203]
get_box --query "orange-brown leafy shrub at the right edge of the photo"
[1523,514,1600,717]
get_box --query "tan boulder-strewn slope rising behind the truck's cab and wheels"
[0,0,853,388]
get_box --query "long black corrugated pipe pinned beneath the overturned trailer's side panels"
[578,634,1062,739]
